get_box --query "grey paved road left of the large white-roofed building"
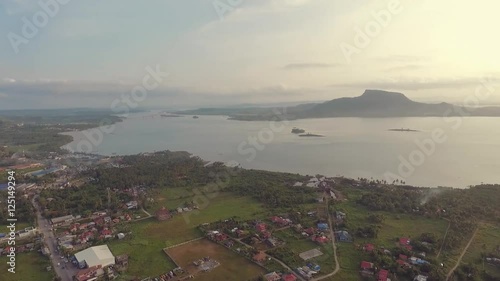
[31,196,78,281]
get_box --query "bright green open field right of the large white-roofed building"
[109,193,267,277]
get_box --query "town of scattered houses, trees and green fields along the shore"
[0,151,500,281]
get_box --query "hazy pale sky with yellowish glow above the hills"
[0,0,500,109]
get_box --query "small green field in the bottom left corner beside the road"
[0,252,53,281]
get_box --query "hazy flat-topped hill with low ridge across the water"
[178,90,500,120]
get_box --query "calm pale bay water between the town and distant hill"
[63,112,500,188]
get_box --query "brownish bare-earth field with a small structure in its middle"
[167,239,265,281]
